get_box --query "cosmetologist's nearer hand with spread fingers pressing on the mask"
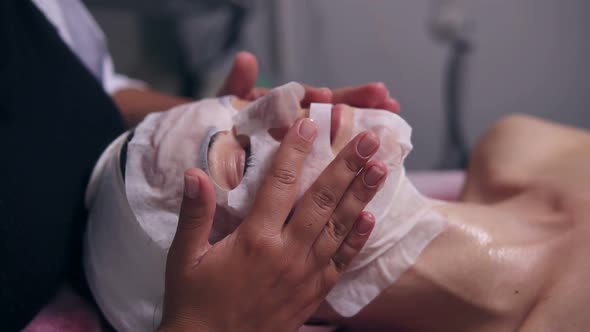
[160,119,387,332]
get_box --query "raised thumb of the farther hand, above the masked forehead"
[218,52,258,99]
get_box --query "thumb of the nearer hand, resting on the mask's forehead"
[170,168,215,258]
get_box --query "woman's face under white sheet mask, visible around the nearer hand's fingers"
[125,83,411,242]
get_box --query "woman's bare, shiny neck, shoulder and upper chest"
[318,116,590,332]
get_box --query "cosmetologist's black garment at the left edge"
[0,0,124,331]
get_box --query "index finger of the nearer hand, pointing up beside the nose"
[243,118,317,234]
